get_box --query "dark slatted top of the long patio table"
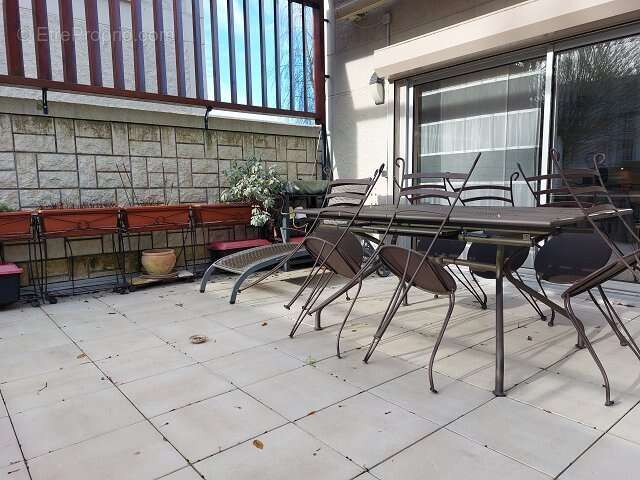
[300,205,631,231]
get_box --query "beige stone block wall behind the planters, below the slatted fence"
[0,110,320,288]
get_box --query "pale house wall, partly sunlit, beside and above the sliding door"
[328,0,636,201]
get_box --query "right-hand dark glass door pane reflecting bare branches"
[554,36,640,244]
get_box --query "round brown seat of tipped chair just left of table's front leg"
[378,245,456,295]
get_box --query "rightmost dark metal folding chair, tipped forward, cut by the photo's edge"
[505,150,640,406]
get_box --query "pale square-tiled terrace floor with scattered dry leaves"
[0,272,640,480]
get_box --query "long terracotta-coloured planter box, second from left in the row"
[38,207,120,238]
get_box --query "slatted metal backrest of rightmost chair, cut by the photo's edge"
[550,149,640,286]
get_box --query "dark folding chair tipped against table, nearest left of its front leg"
[364,153,480,393]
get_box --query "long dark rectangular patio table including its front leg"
[300,204,631,397]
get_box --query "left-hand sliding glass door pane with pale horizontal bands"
[413,58,546,205]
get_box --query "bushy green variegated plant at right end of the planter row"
[222,158,282,227]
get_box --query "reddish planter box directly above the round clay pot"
[123,205,191,232]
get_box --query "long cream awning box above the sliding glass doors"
[374,0,640,80]
